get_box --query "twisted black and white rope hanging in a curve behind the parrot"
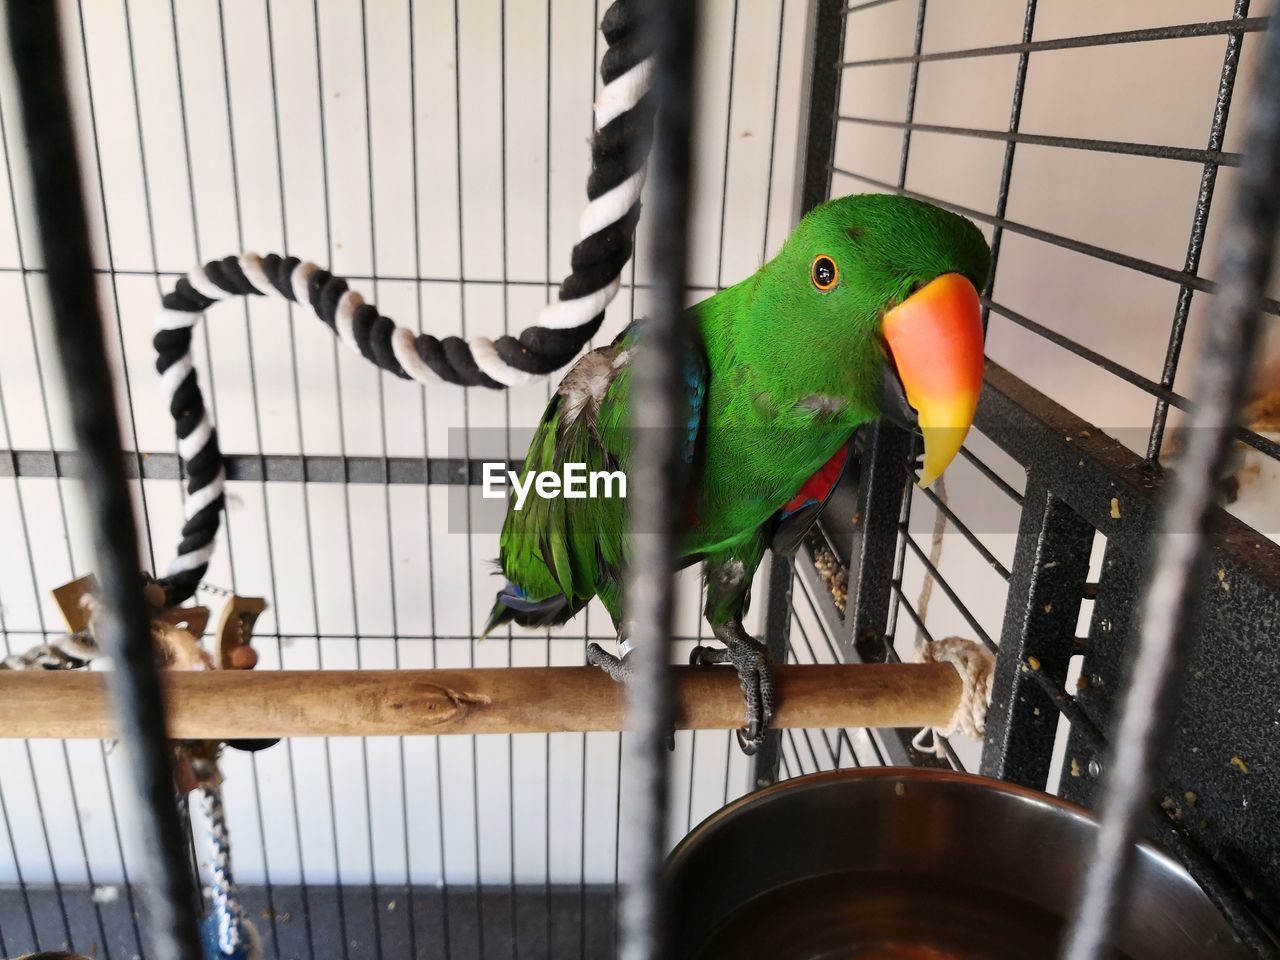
[155,0,654,604]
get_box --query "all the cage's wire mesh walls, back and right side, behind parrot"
[0,0,1280,957]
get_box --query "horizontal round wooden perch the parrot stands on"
[0,663,961,740]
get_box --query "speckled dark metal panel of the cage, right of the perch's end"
[978,364,1280,920]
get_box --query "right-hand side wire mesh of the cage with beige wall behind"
[832,0,1280,791]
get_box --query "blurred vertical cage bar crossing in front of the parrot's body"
[620,0,698,960]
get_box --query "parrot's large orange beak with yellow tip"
[882,274,983,486]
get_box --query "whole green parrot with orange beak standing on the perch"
[484,195,991,753]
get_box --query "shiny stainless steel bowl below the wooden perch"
[667,767,1249,960]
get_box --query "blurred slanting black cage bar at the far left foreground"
[8,4,201,960]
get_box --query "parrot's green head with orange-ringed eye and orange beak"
[750,193,991,485]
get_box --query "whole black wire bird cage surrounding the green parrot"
[0,0,1280,960]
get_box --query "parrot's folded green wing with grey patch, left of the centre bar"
[486,325,707,632]
